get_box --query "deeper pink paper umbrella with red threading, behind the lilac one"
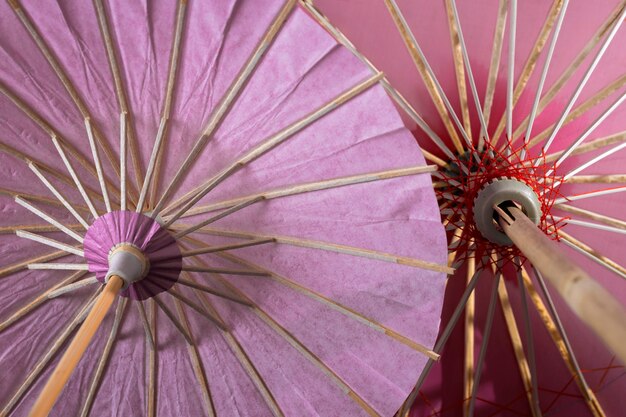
[310,0,626,416]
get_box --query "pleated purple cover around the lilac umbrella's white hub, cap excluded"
[84,211,182,300]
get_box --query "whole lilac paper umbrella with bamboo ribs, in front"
[0,0,451,417]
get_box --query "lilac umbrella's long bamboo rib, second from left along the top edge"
[93,0,143,193]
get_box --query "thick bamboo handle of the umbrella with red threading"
[496,207,626,363]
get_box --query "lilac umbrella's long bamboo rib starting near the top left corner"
[8,0,119,188]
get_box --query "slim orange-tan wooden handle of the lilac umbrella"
[29,275,124,417]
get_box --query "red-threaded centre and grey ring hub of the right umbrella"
[438,144,561,263]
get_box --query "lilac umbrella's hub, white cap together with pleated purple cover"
[84,211,182,300]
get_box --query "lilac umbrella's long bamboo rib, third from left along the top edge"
[149,0,187,206]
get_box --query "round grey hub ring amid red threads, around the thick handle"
[473,178,542,246]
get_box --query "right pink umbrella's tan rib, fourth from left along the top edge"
[492,0,564,144]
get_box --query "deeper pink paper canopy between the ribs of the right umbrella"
[314,0,626,416]
